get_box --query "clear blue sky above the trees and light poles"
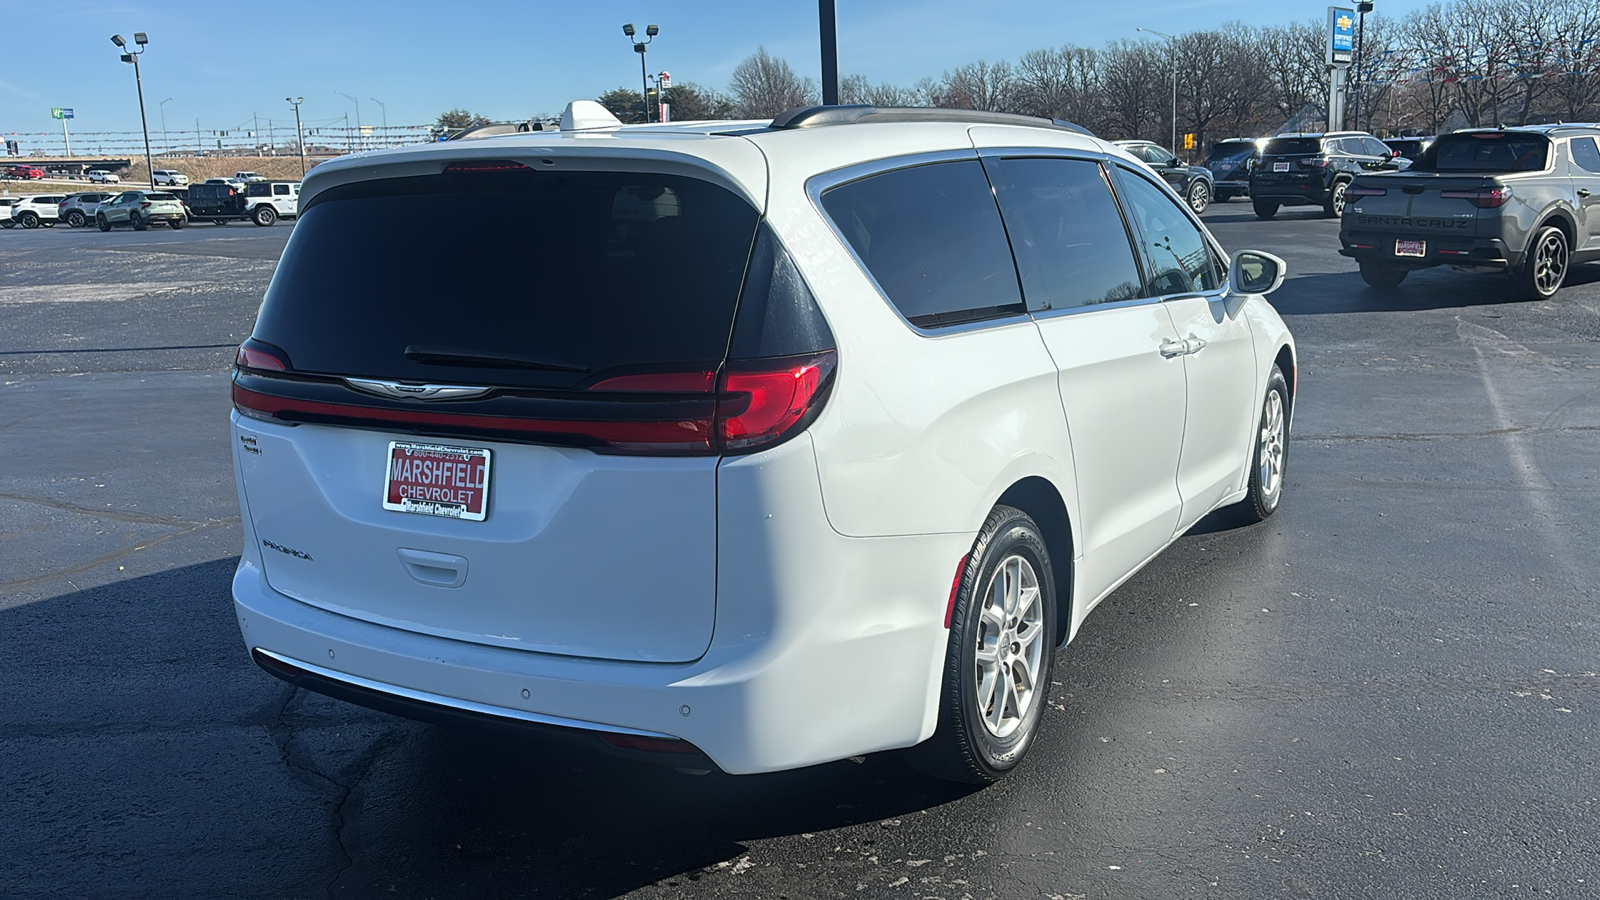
[0,0,1424,135]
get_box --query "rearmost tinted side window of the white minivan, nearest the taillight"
[822,160,1024,328]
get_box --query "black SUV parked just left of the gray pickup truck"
[1250,131,1411,219]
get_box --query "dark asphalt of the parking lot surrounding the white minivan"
[9,202,1600,900]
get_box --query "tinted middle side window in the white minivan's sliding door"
[987,159,1144,311]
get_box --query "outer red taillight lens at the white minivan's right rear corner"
[717,351,838,452]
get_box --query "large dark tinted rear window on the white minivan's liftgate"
[254,171,757,388]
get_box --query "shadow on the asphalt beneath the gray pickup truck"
[1267,263,1600,317]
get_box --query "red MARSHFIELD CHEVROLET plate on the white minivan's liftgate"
[384,440,490,522]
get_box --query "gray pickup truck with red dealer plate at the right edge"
[1339,125,1600,299]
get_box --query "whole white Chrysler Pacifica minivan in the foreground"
[232,104,1294,783]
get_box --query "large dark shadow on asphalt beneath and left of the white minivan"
[0,559,976,897]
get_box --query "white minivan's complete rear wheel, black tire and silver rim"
[906,506,1056,785]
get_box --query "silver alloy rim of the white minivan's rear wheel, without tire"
[974,554,1045,738]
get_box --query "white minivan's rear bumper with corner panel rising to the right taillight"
[234,436,973,773]
